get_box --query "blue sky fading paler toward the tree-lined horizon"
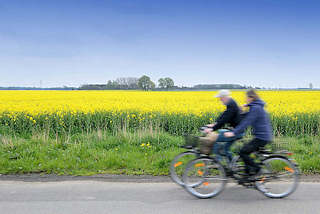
[0,0,320,87]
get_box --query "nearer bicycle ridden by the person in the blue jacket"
[183,146,300,198]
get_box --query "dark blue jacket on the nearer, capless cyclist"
[233,100,272,141]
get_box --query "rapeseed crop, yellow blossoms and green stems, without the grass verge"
[0,91,320,136]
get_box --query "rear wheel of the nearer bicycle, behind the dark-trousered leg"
[256,156,299,198]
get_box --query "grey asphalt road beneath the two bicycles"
[0,181,320,214]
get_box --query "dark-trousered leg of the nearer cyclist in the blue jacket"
[240,138,268,174]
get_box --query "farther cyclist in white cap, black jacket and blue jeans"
[200,90,241,161]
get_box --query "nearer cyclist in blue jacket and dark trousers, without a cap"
[224,90,272,175]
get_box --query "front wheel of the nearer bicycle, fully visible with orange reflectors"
[183,157,227,198]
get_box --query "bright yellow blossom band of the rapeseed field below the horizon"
[0,91,320,115]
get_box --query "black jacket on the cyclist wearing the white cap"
[212,99,240,131]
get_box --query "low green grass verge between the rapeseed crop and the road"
[0,131,320,175]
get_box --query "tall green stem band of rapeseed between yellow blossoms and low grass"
[0,111,320,137]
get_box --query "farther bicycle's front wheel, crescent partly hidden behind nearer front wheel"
[170,151,197,186]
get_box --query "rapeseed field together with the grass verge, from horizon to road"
[0,91,320,175]
